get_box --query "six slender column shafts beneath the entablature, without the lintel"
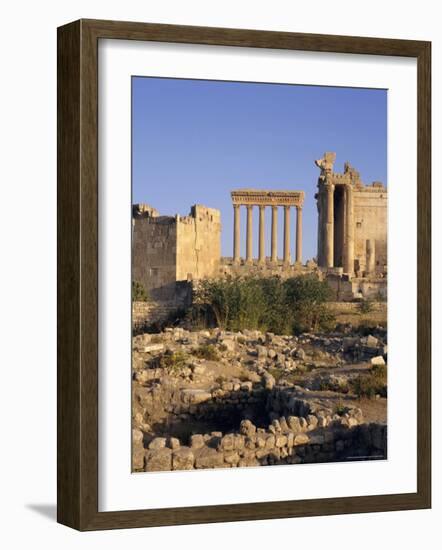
[233,204,302,264]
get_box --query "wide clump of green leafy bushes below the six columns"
[190,275,334,334]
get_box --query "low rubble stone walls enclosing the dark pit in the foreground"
[133,382,387,471]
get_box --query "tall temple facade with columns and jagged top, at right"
[315,152,388,277]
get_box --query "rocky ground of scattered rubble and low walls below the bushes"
[133,328,387,471]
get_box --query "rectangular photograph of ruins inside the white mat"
[128,76,389,472]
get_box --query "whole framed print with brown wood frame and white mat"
[58,20,431,530]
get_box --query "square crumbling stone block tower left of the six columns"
[132,204,221,305]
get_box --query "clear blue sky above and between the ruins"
[132,77,387,260]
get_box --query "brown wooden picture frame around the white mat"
[57,20,431,531]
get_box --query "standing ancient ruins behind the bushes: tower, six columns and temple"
[132,153,387,314]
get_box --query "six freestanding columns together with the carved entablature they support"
[231,189,304,265]
